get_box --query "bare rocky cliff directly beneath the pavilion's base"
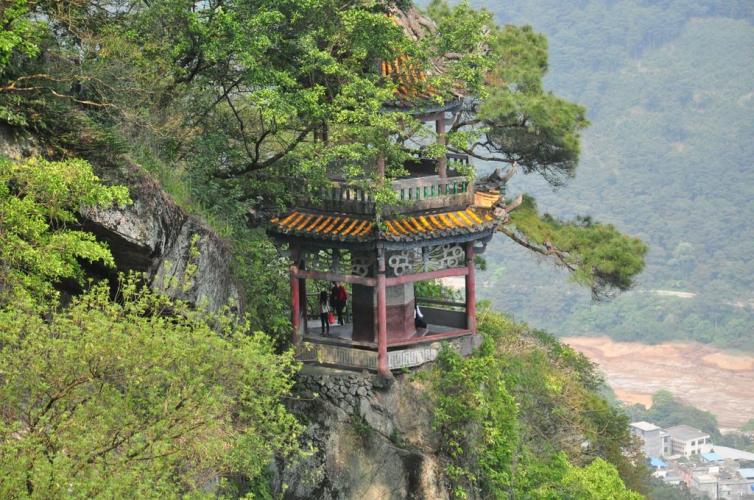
[274,367,448,500]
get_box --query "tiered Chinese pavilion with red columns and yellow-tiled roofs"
[269,11,499,376]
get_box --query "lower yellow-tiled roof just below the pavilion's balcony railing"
[271,208,495,241]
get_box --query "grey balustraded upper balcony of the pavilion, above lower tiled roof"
[299,154,474,215]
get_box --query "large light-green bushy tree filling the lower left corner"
[0,276,299,498]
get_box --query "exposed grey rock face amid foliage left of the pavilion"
[0,124,243,311]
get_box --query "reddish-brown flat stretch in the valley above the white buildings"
[561,337,754,428]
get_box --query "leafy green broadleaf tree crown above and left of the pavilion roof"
[47,0,412,206]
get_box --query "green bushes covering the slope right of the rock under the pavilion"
[430,309,646,498]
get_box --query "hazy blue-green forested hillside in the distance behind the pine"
[473,0,754,350]
